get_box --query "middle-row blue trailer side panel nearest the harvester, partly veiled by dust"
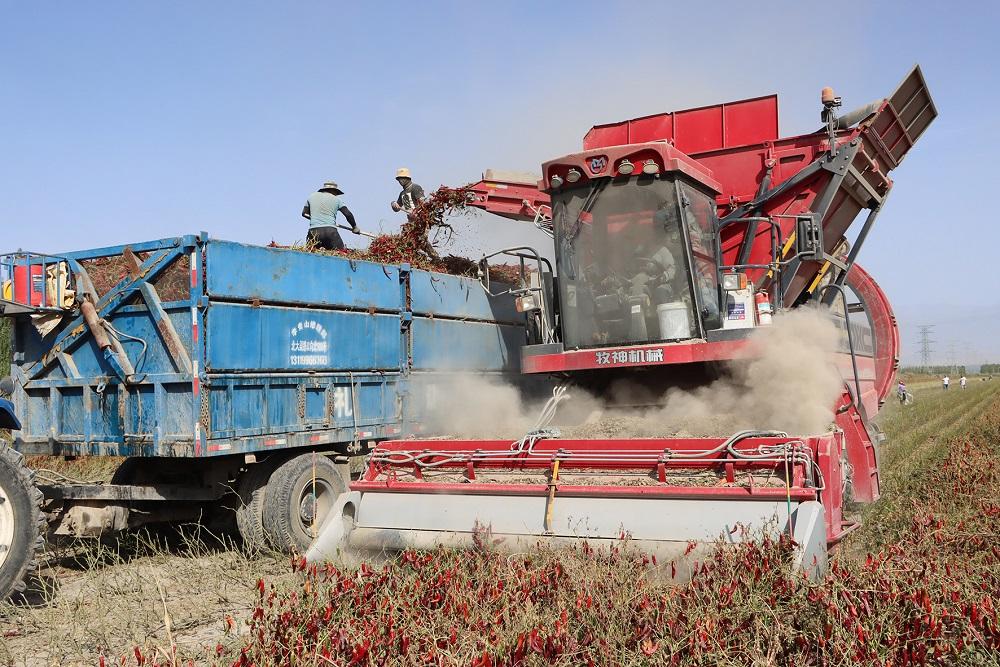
[412,317,524,371]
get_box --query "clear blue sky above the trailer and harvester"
[0,0,1000,363]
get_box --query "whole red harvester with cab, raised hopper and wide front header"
[309,67,937,575]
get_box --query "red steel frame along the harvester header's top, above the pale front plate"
[351,431,849,541]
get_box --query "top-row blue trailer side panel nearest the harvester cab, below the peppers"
[410,271,524,323]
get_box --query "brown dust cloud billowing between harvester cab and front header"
[428,308,844,439]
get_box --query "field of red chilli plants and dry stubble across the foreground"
[0,378,1000,667]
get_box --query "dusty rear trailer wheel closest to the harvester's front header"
[263,453,347,553]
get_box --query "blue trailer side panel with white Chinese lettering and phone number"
[206,303,401,371]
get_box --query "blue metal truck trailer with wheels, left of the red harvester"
[0,233,540,592]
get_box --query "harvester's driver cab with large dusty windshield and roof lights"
[550,144,723,349]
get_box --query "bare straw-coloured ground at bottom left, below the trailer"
[0,531,290,667]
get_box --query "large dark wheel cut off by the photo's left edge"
[0,446,45,599]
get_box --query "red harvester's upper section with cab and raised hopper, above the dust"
[473,67,937,392]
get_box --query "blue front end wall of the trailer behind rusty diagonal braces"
[14,245,197,456]
